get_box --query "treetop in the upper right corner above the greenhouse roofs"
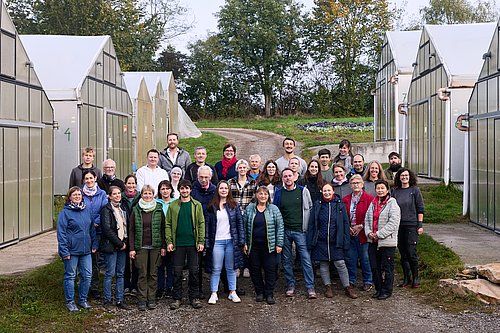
[420,0,498,24]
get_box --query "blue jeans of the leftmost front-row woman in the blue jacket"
[63,254,92,303]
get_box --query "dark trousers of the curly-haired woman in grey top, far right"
[398,226,418,278]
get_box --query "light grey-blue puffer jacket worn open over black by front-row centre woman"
[244,202,285,253]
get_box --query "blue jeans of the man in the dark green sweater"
[283,229,314,289]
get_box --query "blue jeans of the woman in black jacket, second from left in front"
[102,251,127,302]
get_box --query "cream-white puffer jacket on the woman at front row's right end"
[365,198,401,248]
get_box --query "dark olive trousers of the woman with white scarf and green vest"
[135,249,161,302]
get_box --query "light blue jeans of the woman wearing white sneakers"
[210,239,236,292]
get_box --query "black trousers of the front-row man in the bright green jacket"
[173,246,199,301]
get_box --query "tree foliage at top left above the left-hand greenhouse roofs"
[7,0,190,71]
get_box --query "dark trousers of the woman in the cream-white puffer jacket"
[368,243,396,295]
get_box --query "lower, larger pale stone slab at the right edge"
[439,279,500,304]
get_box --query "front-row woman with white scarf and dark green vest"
[129,185,167,311]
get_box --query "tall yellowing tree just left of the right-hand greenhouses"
[308,0,391,115]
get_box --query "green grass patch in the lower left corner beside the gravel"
[0,259,109,333]
